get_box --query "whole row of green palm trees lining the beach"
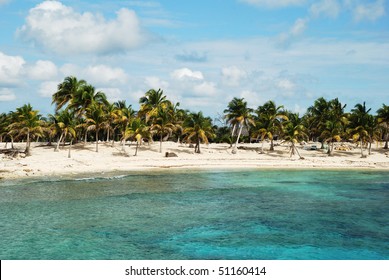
[0,76,389,157]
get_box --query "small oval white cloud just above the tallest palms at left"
[82,65,127,85]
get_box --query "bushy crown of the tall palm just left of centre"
[139,89,170,122]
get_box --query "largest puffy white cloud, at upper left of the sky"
[17,1,148,54]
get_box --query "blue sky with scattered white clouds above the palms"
[0,0,389,117]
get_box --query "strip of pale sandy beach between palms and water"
[0,142,389,180]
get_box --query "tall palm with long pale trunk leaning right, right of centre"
[224,97,254,153]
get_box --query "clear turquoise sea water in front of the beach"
[0,170,389,260]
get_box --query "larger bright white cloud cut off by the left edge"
[0,52,26,86]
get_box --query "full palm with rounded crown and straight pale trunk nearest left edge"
[9,104,44,156]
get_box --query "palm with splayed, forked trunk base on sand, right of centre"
[283,113,308,159]
